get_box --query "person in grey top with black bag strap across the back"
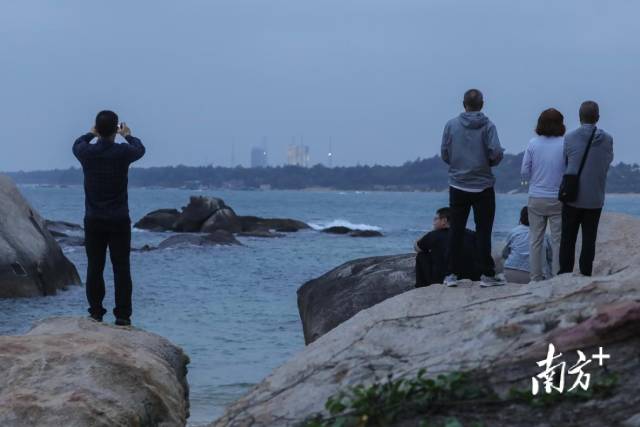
[559,101,613,276]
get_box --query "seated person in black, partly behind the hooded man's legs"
[415,208,480,288]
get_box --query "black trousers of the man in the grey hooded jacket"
[447,187,496,277]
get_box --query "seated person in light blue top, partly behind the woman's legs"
[502,206,552,283]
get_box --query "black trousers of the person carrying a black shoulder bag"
[558,204,602,276]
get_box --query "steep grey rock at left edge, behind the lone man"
[0,175,81,298]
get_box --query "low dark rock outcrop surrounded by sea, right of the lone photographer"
[134,196,310,237]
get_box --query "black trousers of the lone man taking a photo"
[85,221,132,319]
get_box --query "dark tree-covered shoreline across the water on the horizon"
[8,153,640,193]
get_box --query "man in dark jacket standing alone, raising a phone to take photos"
[73,111,145,326]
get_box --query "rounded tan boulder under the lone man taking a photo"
[0,317,189,427]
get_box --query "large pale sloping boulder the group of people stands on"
[213,215,640,427]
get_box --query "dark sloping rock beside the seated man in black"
[298,254,416,344]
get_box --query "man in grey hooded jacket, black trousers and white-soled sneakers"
[441,89,505,286]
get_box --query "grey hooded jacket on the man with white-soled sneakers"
[441,111,504,190]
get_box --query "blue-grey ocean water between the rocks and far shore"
[0,186,640,425]
